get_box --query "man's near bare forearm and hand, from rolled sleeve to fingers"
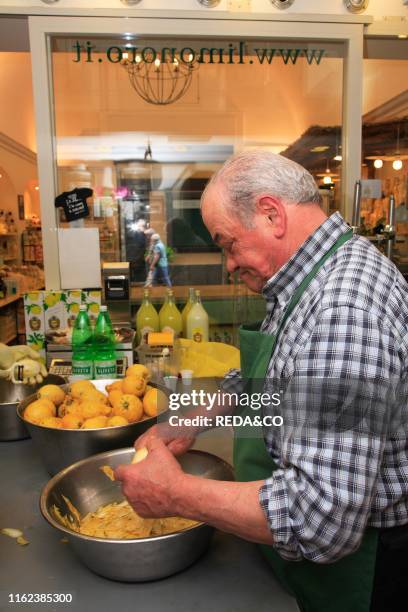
[115,438,273,544]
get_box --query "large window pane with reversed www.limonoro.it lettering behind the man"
[52,35,343,340]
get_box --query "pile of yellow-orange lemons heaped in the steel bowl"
[24,364,167,429]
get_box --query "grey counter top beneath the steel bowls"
[0,432,298,612]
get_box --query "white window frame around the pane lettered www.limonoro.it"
[29,13,367,289]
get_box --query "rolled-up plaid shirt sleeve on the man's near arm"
[259,308,402,563]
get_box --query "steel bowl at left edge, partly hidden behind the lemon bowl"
[0,374,65,442]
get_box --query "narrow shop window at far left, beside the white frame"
[0,17,44,344]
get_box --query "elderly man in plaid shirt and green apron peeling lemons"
[117,151,408,612]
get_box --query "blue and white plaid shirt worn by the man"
[222,213,408,563]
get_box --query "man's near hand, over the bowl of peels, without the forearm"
[115,437,185,518]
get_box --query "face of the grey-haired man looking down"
[201,184,280,293]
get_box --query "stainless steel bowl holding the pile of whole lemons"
[17,380,166,476]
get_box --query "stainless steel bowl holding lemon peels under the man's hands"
[40,448,233,582]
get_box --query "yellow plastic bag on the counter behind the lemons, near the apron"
[174,338,240,378]
